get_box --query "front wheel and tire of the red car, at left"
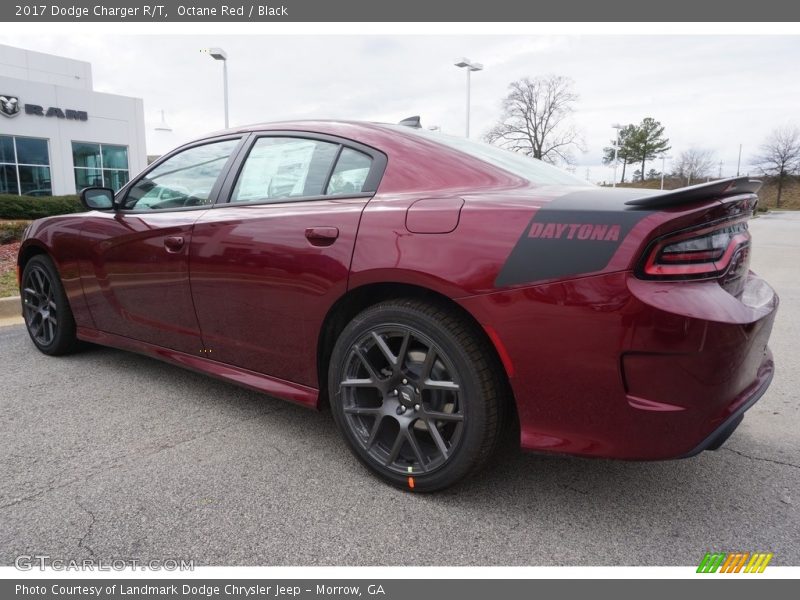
[20,254,78,356]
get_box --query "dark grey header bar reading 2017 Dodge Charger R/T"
[0,0,800,22]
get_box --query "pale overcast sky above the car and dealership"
[0,32,800,182]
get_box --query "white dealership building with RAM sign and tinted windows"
[0,45,147,196]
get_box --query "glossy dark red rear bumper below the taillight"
[462,273,778,460]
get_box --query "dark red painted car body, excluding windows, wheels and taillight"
[20,122,777,468]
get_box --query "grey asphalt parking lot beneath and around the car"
[0,213,800,565]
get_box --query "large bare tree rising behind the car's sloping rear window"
[485,75,585,164]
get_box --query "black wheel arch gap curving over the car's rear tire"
[317,282,516,412]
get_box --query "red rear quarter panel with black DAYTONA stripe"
[350,186,751,298]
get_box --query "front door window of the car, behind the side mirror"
[124,139,239,210]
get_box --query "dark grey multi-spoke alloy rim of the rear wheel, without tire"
[339,324,467,475]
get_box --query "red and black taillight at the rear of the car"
[639,218,750,279]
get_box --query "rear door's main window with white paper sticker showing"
[231,137,339,202]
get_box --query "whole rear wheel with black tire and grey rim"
[328,299,508,492]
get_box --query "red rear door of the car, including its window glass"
[190,132,386,386]
